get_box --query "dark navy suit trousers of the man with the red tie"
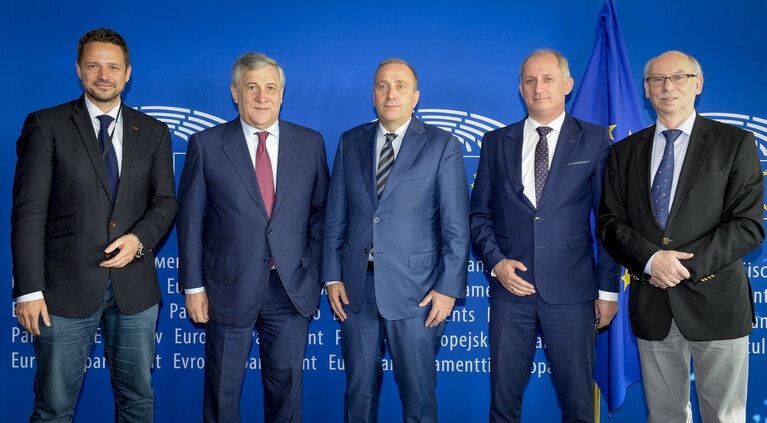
[203,271,309,423]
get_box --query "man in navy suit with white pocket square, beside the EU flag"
[471,50,619,422]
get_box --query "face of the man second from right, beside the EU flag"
[519,53,573,125]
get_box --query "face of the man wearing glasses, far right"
[644,51,703,129]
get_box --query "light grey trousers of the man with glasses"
[637,320,748,423]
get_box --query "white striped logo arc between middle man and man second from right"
[415,109,506,158]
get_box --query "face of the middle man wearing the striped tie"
[373,63,421,132]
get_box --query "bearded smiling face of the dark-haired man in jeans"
[76,41,131,112]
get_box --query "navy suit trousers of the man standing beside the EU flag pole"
[490,294,596,422]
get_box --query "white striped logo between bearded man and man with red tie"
[137,106,226,176]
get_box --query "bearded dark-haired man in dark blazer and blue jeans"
[11,29,176,422]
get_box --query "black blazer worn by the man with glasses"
[597,116,765,341]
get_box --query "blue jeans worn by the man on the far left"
[29,282,158,423]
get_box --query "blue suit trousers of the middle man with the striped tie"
[341,271,445,423]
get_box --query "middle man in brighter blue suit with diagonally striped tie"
[322,59,469,422]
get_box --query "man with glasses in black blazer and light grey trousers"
[597,51,765,422]
